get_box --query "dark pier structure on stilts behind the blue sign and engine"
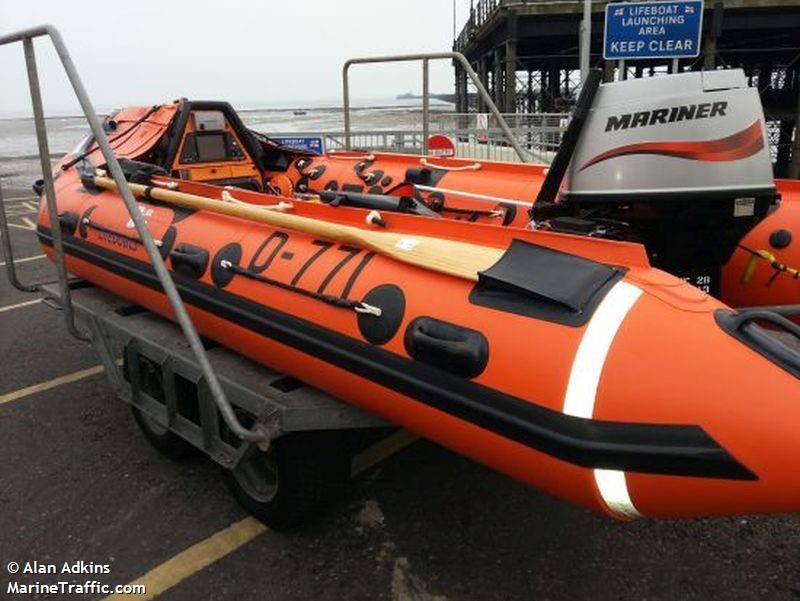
[453,0,800,178]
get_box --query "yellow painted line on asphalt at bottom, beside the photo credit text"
[106,517,267,601]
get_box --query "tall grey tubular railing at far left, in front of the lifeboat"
[0,25,269,442]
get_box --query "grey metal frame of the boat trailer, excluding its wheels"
[41,283,393,468]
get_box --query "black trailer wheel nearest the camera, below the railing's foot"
[226,431,350,529]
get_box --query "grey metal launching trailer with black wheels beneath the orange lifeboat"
[36,281,395,527]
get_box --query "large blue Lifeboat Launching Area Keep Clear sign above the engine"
[603,0,703,60]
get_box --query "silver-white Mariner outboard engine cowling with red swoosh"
[562,69,775,203]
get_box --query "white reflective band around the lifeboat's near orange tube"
[564,281,642,518]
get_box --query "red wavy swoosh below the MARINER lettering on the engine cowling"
[580,121,764,171]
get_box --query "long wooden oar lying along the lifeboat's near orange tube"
[94,177,505,281]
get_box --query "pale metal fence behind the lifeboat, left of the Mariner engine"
[265,113,569,162]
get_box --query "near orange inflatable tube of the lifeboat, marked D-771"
[34,166,800,518]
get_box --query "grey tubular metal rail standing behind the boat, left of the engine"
[342,52,528,163]
